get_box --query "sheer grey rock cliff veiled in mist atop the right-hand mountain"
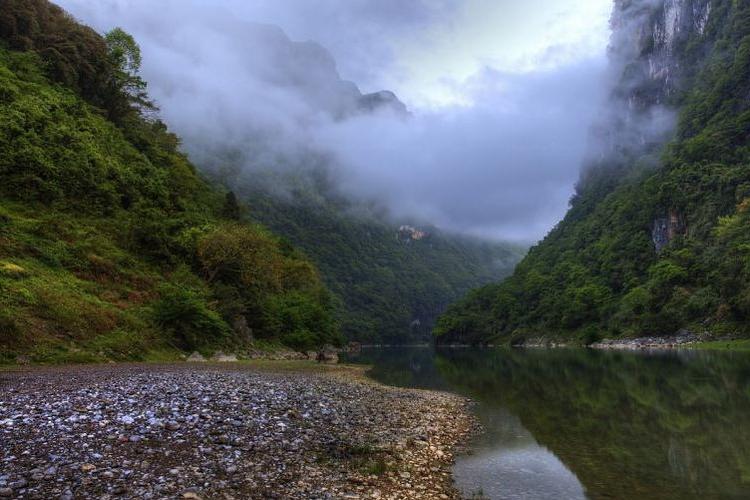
[587,0,712,164]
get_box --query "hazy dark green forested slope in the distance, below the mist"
[248,188,523,344]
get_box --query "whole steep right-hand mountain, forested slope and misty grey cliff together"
[435,0,750,343]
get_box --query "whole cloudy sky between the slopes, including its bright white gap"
[58,0,612,242]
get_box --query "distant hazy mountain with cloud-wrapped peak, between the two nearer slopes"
[178,22,524,344]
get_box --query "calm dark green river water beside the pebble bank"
[348,348,750,500]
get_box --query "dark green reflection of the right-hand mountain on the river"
[436,350,750,499]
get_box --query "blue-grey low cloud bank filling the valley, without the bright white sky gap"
[61,0,606,242]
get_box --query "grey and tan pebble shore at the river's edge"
[0,362,474,500]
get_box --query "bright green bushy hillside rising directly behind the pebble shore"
[0,0,341,361]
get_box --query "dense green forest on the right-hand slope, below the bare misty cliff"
[435,0,750,343]
